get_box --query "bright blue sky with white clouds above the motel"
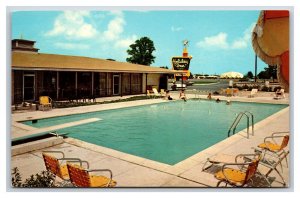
[11,10,267,75]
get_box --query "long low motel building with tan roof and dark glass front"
[11,39,179,105]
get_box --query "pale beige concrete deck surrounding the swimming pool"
[11,93,291,187]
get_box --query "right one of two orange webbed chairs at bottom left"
[67,162,117,187]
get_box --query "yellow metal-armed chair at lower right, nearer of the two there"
[215,154,264,187]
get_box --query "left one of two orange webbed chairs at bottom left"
[42,151,88,185]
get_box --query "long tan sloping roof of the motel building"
[12,51,184,74]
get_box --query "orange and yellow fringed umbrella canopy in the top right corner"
[252,10,289,89]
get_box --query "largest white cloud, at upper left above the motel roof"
[45,11,97,39]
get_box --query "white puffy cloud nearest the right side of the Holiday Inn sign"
[197,32,229,49]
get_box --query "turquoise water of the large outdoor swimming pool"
[23,100,287,165]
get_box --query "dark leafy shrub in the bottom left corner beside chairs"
[11,167,55,188]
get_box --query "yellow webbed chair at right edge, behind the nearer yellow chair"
[258,132,290,165]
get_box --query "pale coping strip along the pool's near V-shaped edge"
[59,106,290,176]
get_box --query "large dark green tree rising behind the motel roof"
[126,37,155,66]
